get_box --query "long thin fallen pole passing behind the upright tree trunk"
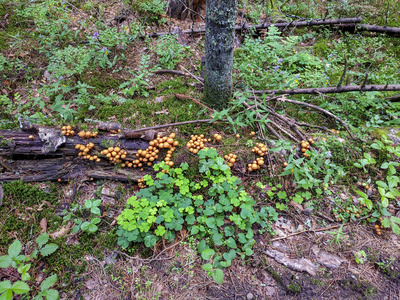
[148,18,362,37]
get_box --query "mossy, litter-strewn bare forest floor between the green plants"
[0,2,400,300]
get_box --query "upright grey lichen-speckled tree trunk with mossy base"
[204,0,237,109]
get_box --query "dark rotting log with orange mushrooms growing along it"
[0,128,154,182]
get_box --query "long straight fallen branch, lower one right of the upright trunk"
[253,84,400,95]
